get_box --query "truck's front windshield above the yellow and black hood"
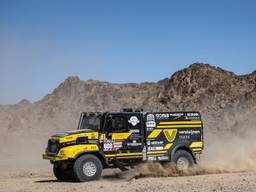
[79,115,100,131]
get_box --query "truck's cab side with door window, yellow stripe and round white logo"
[100,113,143,158]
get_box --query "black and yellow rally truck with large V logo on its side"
[43,110,203,182]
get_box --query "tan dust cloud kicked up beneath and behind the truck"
[122,108,256,180]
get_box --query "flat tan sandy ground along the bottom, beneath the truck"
[0,170,256,192]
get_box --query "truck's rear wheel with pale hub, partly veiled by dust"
[174,150,195,170]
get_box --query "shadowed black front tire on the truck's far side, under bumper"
[53,163,74,181]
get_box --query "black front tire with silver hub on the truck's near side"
[73,154,102,182]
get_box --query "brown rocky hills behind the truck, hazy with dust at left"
[0,63,256,166]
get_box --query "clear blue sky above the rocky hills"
[0,0,256,104]
